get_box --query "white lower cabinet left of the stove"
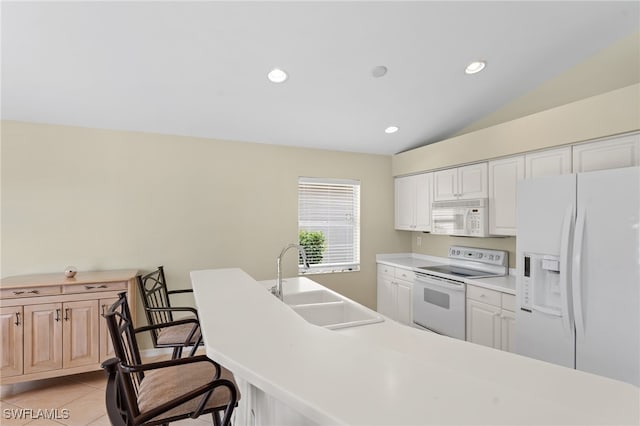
[377,264,415,325]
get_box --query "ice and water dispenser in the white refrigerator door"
[520,253,562,315]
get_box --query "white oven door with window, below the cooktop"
[413,273,466,340]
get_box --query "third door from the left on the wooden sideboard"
[62,300,99,368]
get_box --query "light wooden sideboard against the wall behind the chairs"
[0,270,137,384]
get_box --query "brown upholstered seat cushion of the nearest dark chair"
[138,361,240,420]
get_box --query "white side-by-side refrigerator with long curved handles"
[515,167,640,386]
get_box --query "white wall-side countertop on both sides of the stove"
[376,253,516,294]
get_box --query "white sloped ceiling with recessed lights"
[1,1,640,154]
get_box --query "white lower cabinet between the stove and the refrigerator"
[467,284,515,352]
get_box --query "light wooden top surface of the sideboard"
[0,269,138,288]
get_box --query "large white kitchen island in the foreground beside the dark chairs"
[191,269,640,425]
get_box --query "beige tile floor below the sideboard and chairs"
[0,354,213,426]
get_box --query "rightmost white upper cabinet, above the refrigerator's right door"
[573,134,640,173]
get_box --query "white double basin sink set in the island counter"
[283,285,384,330]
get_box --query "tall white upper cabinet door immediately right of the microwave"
[489,155,524,235]
